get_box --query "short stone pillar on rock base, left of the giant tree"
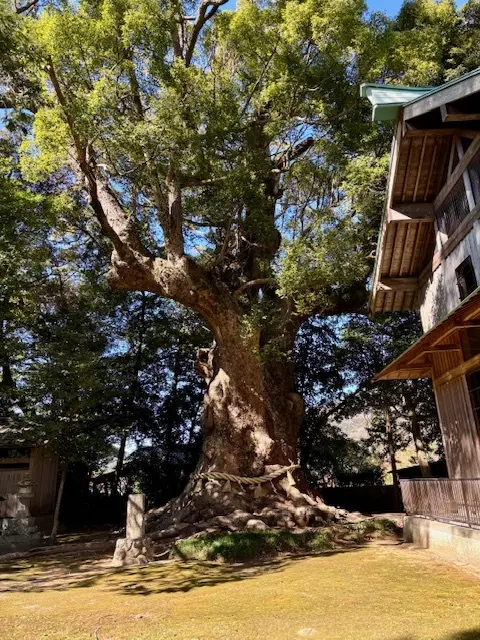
[112,493,153,567]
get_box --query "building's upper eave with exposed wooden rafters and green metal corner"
[360,69,480,314]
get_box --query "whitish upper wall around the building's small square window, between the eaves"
[418,220,480,332]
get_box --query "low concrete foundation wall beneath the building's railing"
[404,516,480,569]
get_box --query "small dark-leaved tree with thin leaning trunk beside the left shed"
[24,288,116,543]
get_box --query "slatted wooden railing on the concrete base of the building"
[400,478,480,528]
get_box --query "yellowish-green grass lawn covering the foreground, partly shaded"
[0,543,480,640]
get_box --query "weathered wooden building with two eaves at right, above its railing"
[361,69,480,478]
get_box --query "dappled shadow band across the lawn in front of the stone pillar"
[0,547,361,596]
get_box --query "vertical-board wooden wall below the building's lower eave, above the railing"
[435,376,480,478]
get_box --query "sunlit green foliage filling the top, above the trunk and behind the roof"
[2,0,478,342]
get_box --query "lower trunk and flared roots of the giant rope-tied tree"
[148,324,338,529]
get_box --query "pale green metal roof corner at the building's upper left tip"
[360,83,437,121]
